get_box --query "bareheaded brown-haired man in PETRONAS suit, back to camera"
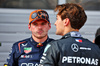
[40,3,100,66]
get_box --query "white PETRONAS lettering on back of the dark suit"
[62,56,99,66]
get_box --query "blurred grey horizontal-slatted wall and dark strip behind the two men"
[0,0,100,66]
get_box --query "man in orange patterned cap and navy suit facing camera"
[7,9,53,66]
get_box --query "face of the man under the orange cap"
[29,20,51,39]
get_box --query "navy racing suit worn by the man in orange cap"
[7,37,53,66]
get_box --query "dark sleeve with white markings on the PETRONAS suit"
[39,43,59,66]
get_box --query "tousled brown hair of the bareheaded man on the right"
[54,3,87,29]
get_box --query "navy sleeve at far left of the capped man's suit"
[7,45,18,66]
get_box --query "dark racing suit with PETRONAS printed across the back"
[40,32,100,66]
